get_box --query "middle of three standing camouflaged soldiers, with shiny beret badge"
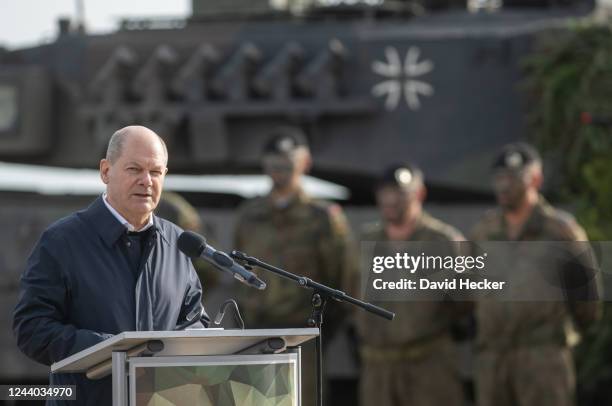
[352,165,464,406]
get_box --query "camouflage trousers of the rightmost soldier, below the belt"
[476,345,576,406]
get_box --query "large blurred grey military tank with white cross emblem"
[0,0,593,394]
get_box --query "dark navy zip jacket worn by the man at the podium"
[13,197,209,406]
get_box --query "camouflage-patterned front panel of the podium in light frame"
[129,353,300,406]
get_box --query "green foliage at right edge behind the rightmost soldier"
[525,19,612,404]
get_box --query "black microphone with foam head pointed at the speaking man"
[178,231,266,290]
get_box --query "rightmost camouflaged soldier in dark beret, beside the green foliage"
[472,143,599,406]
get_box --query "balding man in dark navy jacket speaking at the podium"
[13,126,209,405]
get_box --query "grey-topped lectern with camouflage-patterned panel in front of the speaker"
[51,328,319,406]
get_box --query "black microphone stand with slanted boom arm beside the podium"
[230,250,395,406]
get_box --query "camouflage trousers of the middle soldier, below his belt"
[359,343,463,406]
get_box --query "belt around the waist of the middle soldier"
[360,334,451,362]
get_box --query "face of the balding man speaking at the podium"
[100,134,168,223]
